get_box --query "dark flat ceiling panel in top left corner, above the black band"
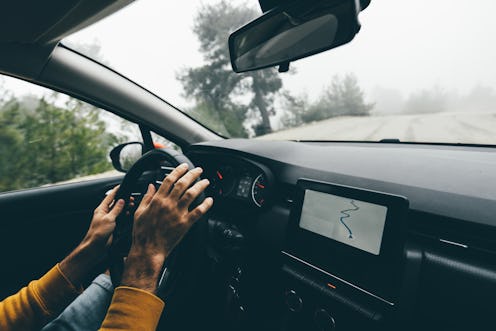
[0,0,132,45]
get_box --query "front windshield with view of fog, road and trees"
[64,0,496,144]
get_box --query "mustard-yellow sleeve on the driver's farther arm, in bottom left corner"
[0,265,79,331]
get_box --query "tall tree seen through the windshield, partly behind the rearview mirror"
[177,1,282,137]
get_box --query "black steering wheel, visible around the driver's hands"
[110,149,208,304]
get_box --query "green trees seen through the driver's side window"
[0,94,118,191]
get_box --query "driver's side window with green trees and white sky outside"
[0,76,141,192]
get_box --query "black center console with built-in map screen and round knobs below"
[282,179,408,330]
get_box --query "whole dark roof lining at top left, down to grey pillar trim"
[0,0,133,82]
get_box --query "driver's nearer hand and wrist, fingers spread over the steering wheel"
[121,164,213,293]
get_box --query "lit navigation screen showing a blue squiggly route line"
[300,190,387,255]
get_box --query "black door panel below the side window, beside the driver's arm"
[0,176,122,297]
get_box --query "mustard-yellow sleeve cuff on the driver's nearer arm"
[100,286,164,331]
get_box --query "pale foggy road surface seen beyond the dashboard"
[259,111,496,145]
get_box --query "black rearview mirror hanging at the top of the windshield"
[229,0,370,72]
